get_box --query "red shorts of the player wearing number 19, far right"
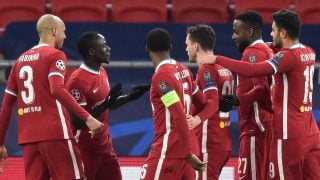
[269,134,320,180]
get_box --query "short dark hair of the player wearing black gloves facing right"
[77,31,101,58]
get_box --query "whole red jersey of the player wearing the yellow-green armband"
[148,59,198,159]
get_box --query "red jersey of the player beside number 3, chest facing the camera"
[66,64,112,153]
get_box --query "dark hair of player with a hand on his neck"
[187,24,216,50]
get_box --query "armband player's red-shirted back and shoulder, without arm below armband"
[150,59,193,158]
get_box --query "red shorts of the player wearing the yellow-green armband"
[140,158,196,180]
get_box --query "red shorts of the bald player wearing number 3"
[23,140,84,180]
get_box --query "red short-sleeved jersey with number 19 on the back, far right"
[267,44,319,139]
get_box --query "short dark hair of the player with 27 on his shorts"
[234,10,263,30]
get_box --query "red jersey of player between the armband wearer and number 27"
[196,64,234,153]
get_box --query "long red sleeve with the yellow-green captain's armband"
[152,73,192,155]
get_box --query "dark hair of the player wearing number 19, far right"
[272,10,301,39]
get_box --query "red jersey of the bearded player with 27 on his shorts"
[236,40,273,135]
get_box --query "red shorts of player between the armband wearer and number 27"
[199,151,230,180]
